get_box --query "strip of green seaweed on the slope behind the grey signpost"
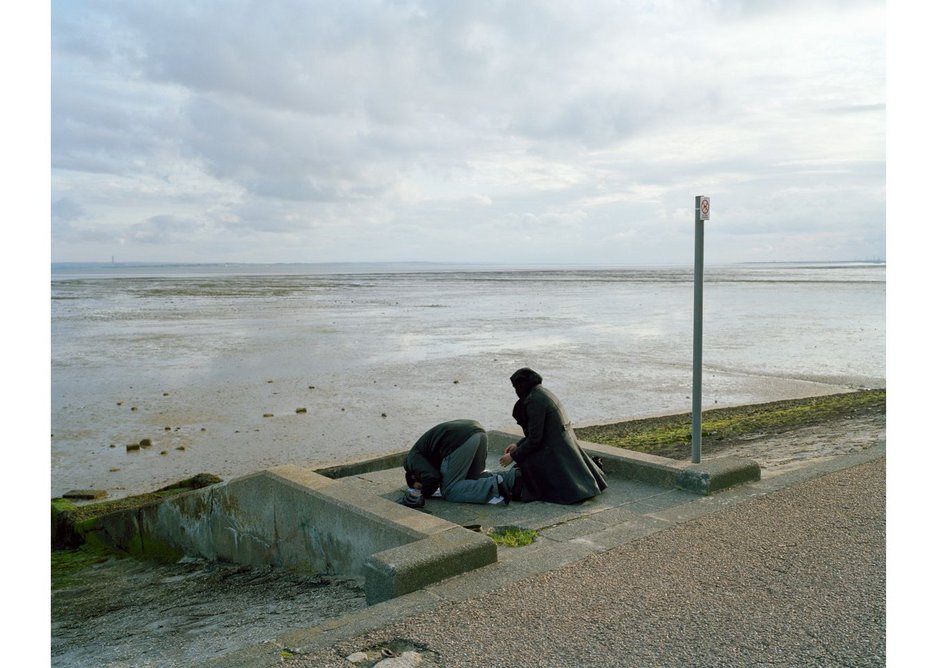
[575,389,887,459]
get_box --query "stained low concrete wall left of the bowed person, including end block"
[94,466,496,604]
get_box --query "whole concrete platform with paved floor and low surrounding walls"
[82,432,760,605]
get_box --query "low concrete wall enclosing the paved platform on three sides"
[79,431,760,604]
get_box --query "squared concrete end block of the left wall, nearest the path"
[364,526,497,605]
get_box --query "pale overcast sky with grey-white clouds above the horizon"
[51,0,886,264]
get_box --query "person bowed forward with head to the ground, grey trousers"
[402,420,516,508]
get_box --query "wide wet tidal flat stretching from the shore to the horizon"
[51,263,886,497]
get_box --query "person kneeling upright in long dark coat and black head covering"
[499,368,607,504]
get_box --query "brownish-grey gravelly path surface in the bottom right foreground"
[285,459,886,668]
